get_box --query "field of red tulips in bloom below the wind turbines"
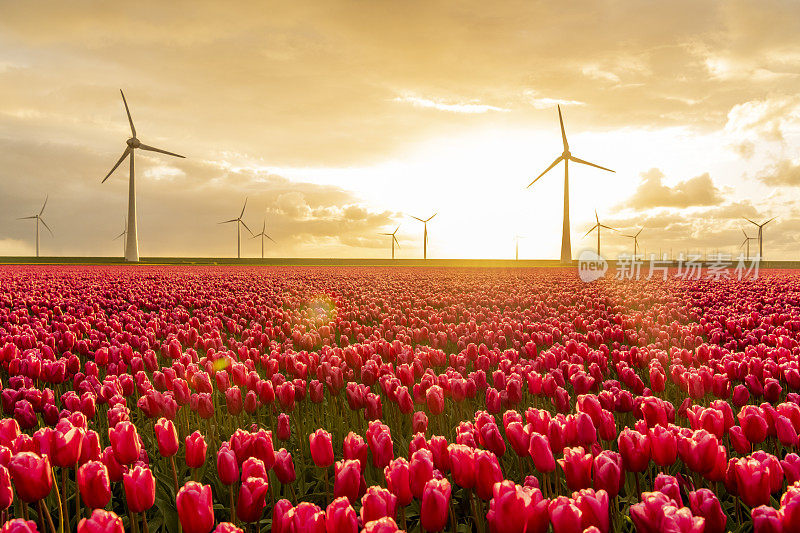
[0,266,800,533]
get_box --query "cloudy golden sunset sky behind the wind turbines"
[0,0,800,259]
